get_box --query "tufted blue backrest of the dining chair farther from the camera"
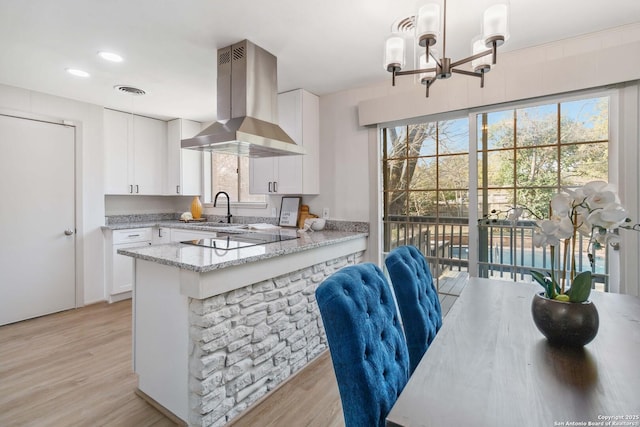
[385,246,442,373]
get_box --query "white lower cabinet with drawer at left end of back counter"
[106,227,152,302]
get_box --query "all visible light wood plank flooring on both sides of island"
[0,273,464,427]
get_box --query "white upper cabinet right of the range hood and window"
[249,89,320,194]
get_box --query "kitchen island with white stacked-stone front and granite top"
[118,230,367,426]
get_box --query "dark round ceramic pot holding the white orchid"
[531,292,600,347]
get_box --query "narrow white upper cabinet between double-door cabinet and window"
[165,119,202,196]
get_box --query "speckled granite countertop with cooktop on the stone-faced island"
[118,231,368,273]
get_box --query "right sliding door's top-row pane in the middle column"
[516,104,558,147]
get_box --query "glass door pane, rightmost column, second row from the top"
[560,143,609,186]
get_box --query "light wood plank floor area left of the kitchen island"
[0,300,174,427]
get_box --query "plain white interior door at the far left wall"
[0,115,76,325]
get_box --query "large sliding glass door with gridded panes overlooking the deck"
[381,96,611,292]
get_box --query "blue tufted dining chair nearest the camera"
[316,263,409,427]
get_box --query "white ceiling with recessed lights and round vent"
[0,0,640,121]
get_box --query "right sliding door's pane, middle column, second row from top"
[515,147,558,187]
